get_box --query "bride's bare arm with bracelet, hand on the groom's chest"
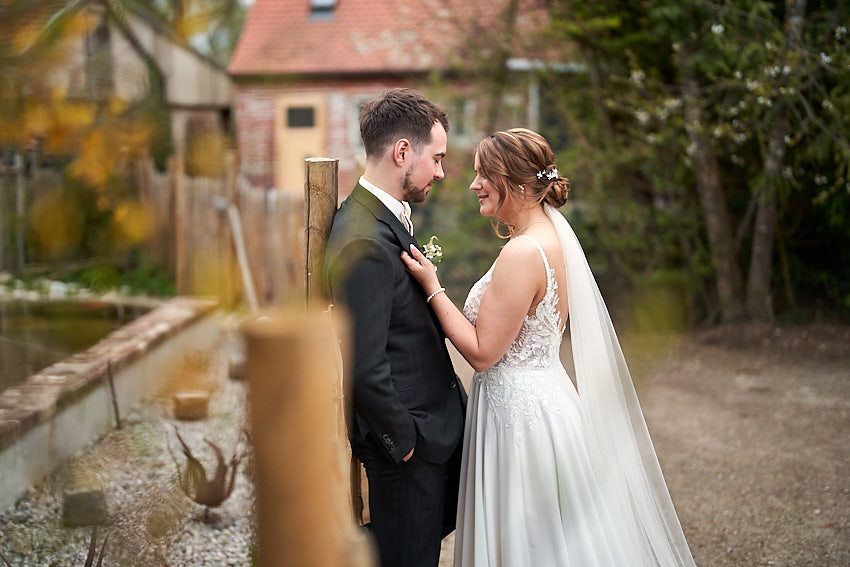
[401,239,546,371]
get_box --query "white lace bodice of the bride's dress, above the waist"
[463,235,564,368]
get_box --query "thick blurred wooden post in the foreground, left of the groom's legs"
[244,312,373,567]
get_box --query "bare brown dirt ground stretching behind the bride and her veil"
[440,325,850,567]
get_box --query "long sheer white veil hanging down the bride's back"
[544,205,695,567]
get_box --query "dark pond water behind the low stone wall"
[0,299,150,391]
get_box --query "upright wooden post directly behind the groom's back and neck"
[304,158,339,306]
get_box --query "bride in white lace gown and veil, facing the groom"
[402,128,694,567]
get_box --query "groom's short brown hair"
[360,88,449,157]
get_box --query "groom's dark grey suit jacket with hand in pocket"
[323,184,466,463]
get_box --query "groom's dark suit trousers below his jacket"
[357,443,462,567]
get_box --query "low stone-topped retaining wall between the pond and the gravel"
[0,297,219,510]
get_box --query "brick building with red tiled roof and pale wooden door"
[228,0,556,196]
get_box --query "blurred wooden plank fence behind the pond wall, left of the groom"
[135,155,305,306]
